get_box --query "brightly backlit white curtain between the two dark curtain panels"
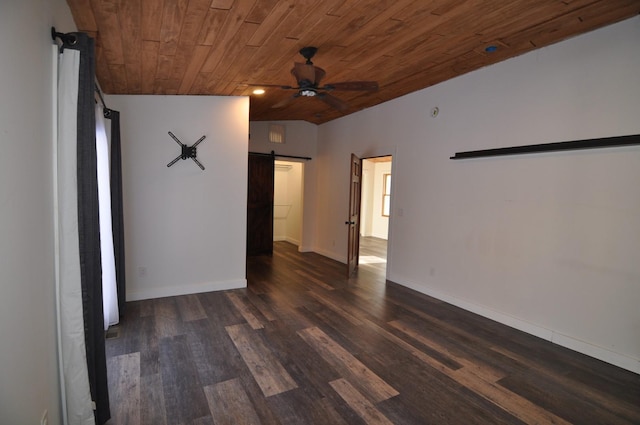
[96,103,119,330]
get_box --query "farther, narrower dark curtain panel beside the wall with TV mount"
[109,110,127,317]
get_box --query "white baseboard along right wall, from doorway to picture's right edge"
[390,277,640,374]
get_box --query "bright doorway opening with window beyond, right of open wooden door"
[358,156,392,274]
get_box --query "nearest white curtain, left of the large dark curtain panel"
[53,46,95,425]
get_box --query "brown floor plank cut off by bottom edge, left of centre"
[204,379,261,425]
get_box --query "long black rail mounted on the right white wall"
[450,134,640,159]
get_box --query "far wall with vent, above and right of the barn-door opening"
[249,121,318,252]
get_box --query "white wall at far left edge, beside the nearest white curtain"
[0,0,75,425]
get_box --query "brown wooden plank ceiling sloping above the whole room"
[67,0,640,124]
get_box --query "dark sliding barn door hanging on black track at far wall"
[247,154,274,256]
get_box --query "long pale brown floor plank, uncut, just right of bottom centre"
[298,327,398,403]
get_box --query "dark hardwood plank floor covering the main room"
[107,242,640,425]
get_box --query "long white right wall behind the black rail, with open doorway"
[316,17,640,372]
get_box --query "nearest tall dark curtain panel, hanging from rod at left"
[65,33,111,425]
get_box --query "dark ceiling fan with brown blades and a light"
[256,46,378,111]
